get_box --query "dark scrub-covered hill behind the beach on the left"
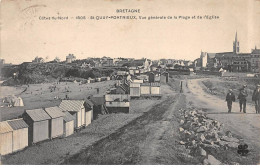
[1,62,115,86]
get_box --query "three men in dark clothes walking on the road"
[226,85,260,113]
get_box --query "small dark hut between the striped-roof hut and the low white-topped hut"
[89,96,107,120]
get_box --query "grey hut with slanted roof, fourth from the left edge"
[44,106,64,139]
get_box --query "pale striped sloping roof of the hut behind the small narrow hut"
[60,100,84,111]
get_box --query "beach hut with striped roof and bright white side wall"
[59,100,85,129]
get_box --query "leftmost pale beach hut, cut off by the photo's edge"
[0,121,13,155]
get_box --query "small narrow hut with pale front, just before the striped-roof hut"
[63,111,75,137]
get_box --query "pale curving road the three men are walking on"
[184,79,260,163]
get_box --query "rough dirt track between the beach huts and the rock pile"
[64,80,203,165]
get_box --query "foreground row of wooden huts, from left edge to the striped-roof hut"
[0,100,93,155]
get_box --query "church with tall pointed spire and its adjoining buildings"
[195,32,260,73]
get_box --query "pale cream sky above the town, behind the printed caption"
[0,0,260,64]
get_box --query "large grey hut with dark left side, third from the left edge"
[23,109,51,144]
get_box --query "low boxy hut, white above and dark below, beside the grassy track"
[105,94,130,113]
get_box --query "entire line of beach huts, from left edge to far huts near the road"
[0,72,169,155]
